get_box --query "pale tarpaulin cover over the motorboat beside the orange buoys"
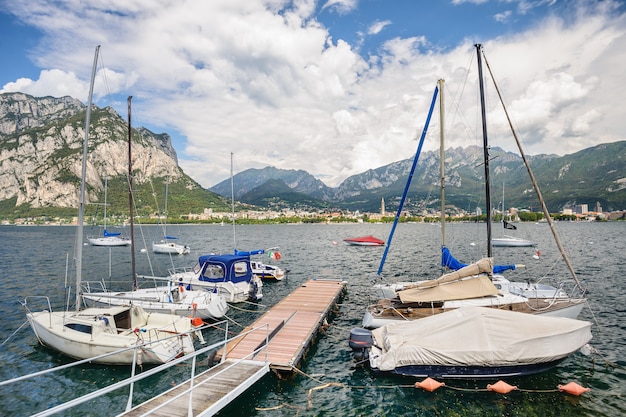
[370,307,591,371]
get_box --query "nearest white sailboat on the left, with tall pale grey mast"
[22,46,196,365]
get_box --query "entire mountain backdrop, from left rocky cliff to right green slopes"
[0,93,626,217]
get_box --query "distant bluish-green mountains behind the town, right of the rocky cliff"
[211,141,626,212]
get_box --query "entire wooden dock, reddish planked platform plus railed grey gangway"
[120,280,346,417]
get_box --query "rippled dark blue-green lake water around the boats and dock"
[0,222,626,416]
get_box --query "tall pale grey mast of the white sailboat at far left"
[75,45,100,311]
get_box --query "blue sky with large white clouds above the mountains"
[0,0,626,188]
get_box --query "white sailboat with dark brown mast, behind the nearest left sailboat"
[82,98,228,320]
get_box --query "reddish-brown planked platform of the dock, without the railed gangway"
[217,280,346,371]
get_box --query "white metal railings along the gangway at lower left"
[0,320,270,417]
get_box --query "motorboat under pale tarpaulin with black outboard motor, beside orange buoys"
[350,307,591,379]
